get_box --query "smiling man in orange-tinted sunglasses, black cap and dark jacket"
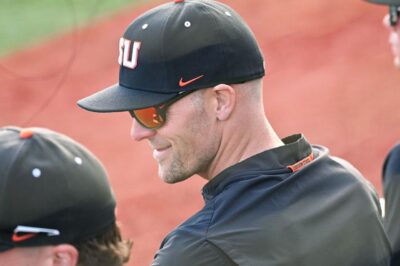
[78,0,390,266]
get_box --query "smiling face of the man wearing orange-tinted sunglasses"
[131,90,219,183]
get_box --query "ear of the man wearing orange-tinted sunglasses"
[213,84,236,121]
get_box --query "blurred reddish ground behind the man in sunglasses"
[0,0,400,265]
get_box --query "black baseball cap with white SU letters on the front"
[78,0,265,112]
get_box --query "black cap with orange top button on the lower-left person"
[0,126,116,251]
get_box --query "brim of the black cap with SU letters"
[78,84,177,113]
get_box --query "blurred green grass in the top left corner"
[0,0,152,57]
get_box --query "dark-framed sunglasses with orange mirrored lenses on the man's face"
[129,91,194,129]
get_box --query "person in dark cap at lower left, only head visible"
[0,127,132,266]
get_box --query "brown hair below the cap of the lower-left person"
[74,223,132,266]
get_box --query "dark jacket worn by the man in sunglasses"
[152,135,391,266]
